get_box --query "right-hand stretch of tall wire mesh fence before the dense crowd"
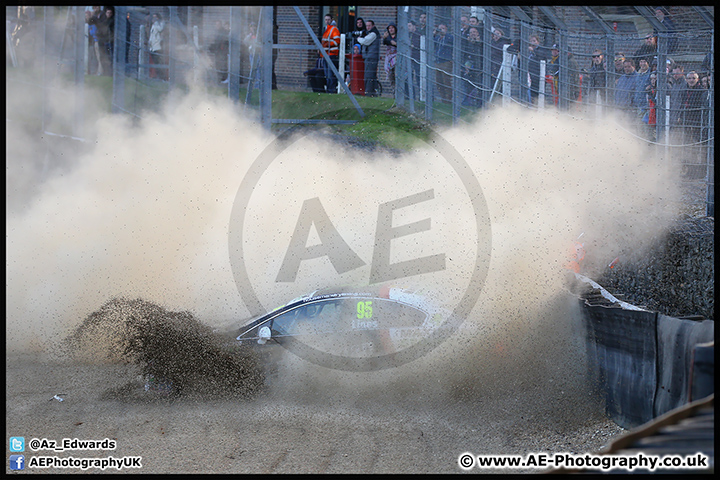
[395,6,715,216]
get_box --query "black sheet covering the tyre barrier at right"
[581,300,715,428]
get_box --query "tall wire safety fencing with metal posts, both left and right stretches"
[6,6,714,216]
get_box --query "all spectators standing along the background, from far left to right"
[10,6,713,143]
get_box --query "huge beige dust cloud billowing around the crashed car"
[6,68,677,413]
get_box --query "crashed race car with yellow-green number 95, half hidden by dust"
[228,286,447,372]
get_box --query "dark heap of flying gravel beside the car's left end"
[65,298,264,397]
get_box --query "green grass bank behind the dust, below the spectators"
[6,68,438,150]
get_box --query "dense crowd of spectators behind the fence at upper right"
[296,7,712,143]
